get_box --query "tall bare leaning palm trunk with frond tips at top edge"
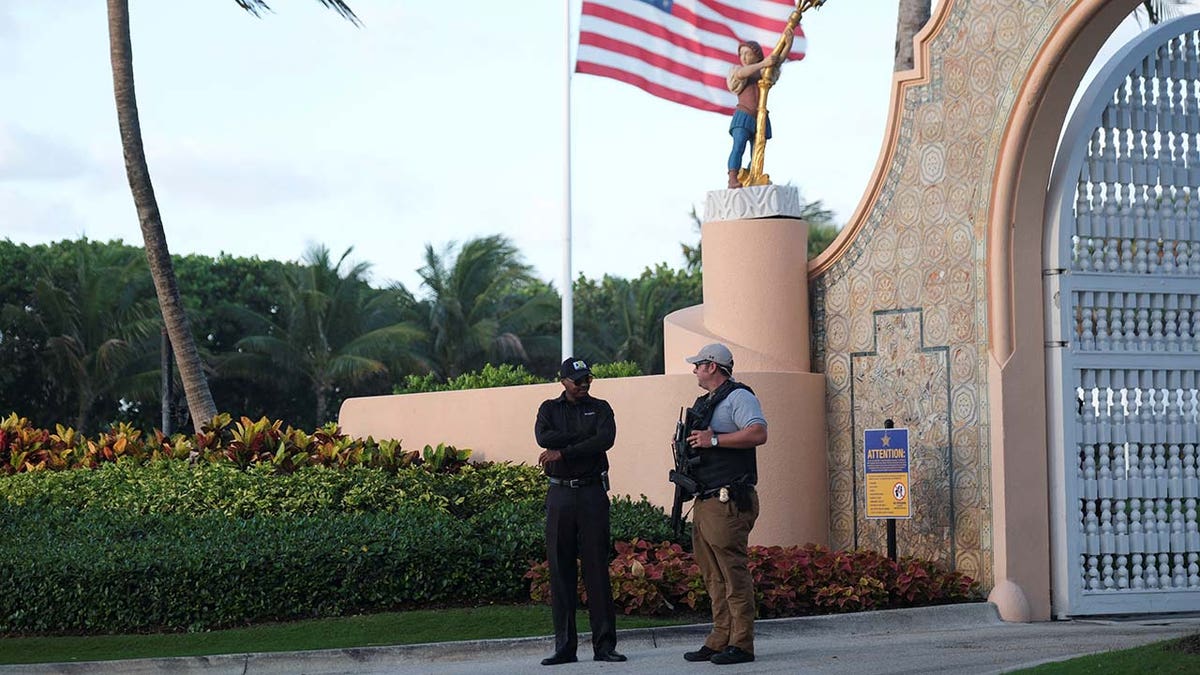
[108,0,358,431]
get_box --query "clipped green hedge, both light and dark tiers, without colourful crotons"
[0,460,686,634]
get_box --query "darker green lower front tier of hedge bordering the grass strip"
[0,506,477,633]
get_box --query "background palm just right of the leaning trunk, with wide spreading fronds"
[221,245,422,424]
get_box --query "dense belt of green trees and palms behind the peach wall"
[0,230,701,434]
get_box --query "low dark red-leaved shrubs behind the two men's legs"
[526,539,982,619]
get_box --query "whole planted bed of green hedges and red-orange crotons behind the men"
[0,416,979,634]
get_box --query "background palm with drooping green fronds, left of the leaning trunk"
[14,239,158,431]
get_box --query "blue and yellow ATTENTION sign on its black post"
[863,419,912,561]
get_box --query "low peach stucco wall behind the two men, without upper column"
[338,372,829,545]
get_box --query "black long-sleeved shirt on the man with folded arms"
[533,393,617,478]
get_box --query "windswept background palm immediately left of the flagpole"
[415,234,558,380]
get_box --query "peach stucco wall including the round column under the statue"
[340,210,829,544]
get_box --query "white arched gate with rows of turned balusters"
[1044,16,1200,616]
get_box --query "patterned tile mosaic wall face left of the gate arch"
[810,0,1073,586]
